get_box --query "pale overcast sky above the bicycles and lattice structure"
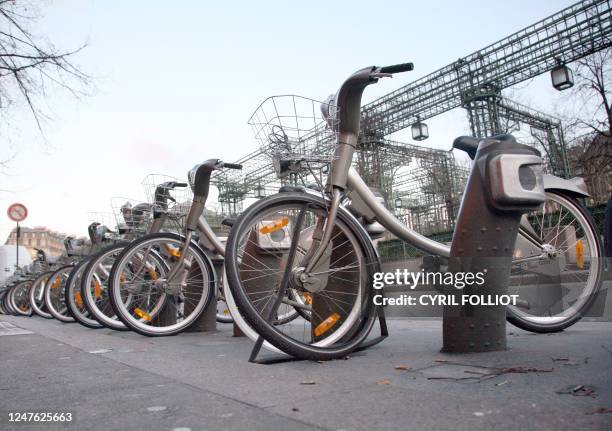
[0,0,573,243]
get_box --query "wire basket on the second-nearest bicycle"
[142,174,193,231]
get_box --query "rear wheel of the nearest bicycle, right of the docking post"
[508,191,604,332]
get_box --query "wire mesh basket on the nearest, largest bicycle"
[249,95,338,177]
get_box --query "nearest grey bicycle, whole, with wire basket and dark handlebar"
[226,63,603,360]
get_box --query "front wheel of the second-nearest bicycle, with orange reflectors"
[110,233,215,336]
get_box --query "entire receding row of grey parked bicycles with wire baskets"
[0,63,604,360]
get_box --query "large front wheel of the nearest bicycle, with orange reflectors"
[226,193,378,360]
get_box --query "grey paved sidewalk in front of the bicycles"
[0,316,612,431]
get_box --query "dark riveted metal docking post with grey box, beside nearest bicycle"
[442,135,545,353]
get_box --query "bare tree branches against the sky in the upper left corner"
[0,0,91,137]
